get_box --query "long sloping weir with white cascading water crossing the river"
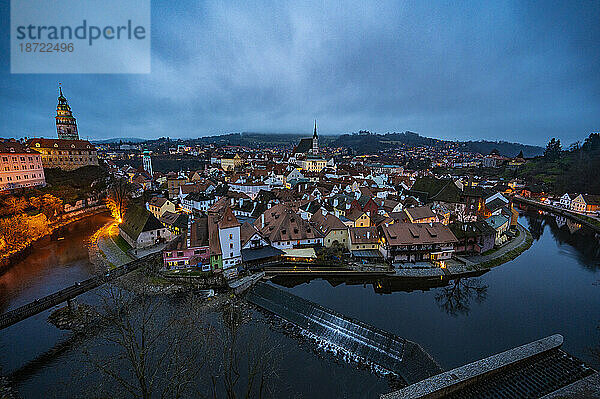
[247,283,442,384]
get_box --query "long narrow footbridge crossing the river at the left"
[0,254,156,330]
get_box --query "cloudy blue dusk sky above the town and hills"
[0,0,600,145]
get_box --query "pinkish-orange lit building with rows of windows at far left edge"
[0,139,46,191]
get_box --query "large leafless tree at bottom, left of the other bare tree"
[79,285,210,399]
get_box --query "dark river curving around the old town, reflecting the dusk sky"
[0,212,600,397]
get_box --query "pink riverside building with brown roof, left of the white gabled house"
[163,215,210,271]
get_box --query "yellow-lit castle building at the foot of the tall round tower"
[28,139,98,170]
